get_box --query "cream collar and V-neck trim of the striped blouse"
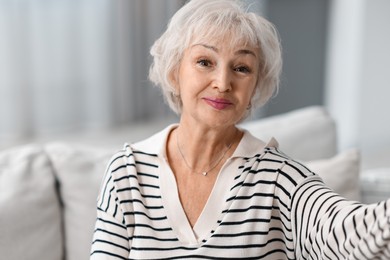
[134,124,270,247]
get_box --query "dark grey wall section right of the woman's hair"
[265,0,329,116]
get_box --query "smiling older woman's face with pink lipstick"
[174,37,259,127]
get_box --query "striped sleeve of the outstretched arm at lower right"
[291,177,390,260]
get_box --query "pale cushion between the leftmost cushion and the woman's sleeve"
[45,143,115,260]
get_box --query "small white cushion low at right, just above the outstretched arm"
[304,149,361,201]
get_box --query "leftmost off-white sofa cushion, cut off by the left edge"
[0,145,63,260]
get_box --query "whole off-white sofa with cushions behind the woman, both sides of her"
[0,107,386,260]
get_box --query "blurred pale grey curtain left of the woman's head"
[0,0,184,146]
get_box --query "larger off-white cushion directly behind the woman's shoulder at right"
[242,106,337,161]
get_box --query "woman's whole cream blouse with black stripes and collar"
[91,125,390,260]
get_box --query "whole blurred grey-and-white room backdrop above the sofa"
[0,0,390,169]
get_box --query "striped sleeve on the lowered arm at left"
[90,154,130,260]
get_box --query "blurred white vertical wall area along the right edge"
[325,0,390,167]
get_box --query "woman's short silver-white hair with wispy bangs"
[149,0,282,114]
